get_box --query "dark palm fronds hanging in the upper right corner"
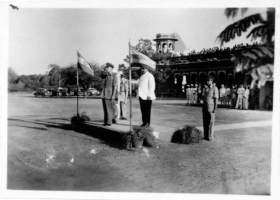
[217,8,275,87]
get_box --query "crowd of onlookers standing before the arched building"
[185,83,250,110]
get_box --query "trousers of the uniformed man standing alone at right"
[203,112,215,140]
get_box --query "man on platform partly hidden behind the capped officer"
[119,75,128,120]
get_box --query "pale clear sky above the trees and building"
[8,2,266,75]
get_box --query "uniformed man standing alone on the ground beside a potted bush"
[202,76,219,141]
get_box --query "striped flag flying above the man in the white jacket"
[130,46,156,71]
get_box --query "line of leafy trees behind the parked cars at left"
[8,63,106,92]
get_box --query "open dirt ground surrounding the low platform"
[7,94,272,195]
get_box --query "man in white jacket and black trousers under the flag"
[137,67,156,126]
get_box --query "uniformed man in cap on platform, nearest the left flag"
[101,63,118,126]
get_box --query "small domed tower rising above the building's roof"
[154,33,178,53]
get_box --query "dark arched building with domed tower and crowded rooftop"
[154,34,273,109]
